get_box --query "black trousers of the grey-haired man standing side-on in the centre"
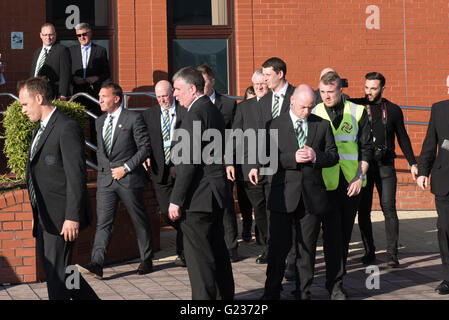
[181,198,235,300]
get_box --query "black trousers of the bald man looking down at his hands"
[264,200,322,299]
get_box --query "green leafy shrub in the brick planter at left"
[1,100,88,179]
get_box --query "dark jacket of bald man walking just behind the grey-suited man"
[142,103,187,183]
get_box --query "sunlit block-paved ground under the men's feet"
[0,211,449,300]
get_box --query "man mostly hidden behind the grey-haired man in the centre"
[197,63,240,262]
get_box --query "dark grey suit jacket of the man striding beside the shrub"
[95,108,150,188]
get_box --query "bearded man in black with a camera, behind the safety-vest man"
[350,72,418,268]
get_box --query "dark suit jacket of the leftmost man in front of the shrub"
[26,110,92,236]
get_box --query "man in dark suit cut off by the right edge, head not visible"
[416,100,449,294]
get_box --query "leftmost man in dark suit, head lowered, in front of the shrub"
[18,78,98,300]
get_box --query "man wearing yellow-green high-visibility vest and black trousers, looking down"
[314,71,373,300]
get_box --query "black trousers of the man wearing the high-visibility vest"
[322,171,360,291]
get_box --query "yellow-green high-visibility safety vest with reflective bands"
[313,101,366,191]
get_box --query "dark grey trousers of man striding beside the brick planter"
[92,180,153,266]
